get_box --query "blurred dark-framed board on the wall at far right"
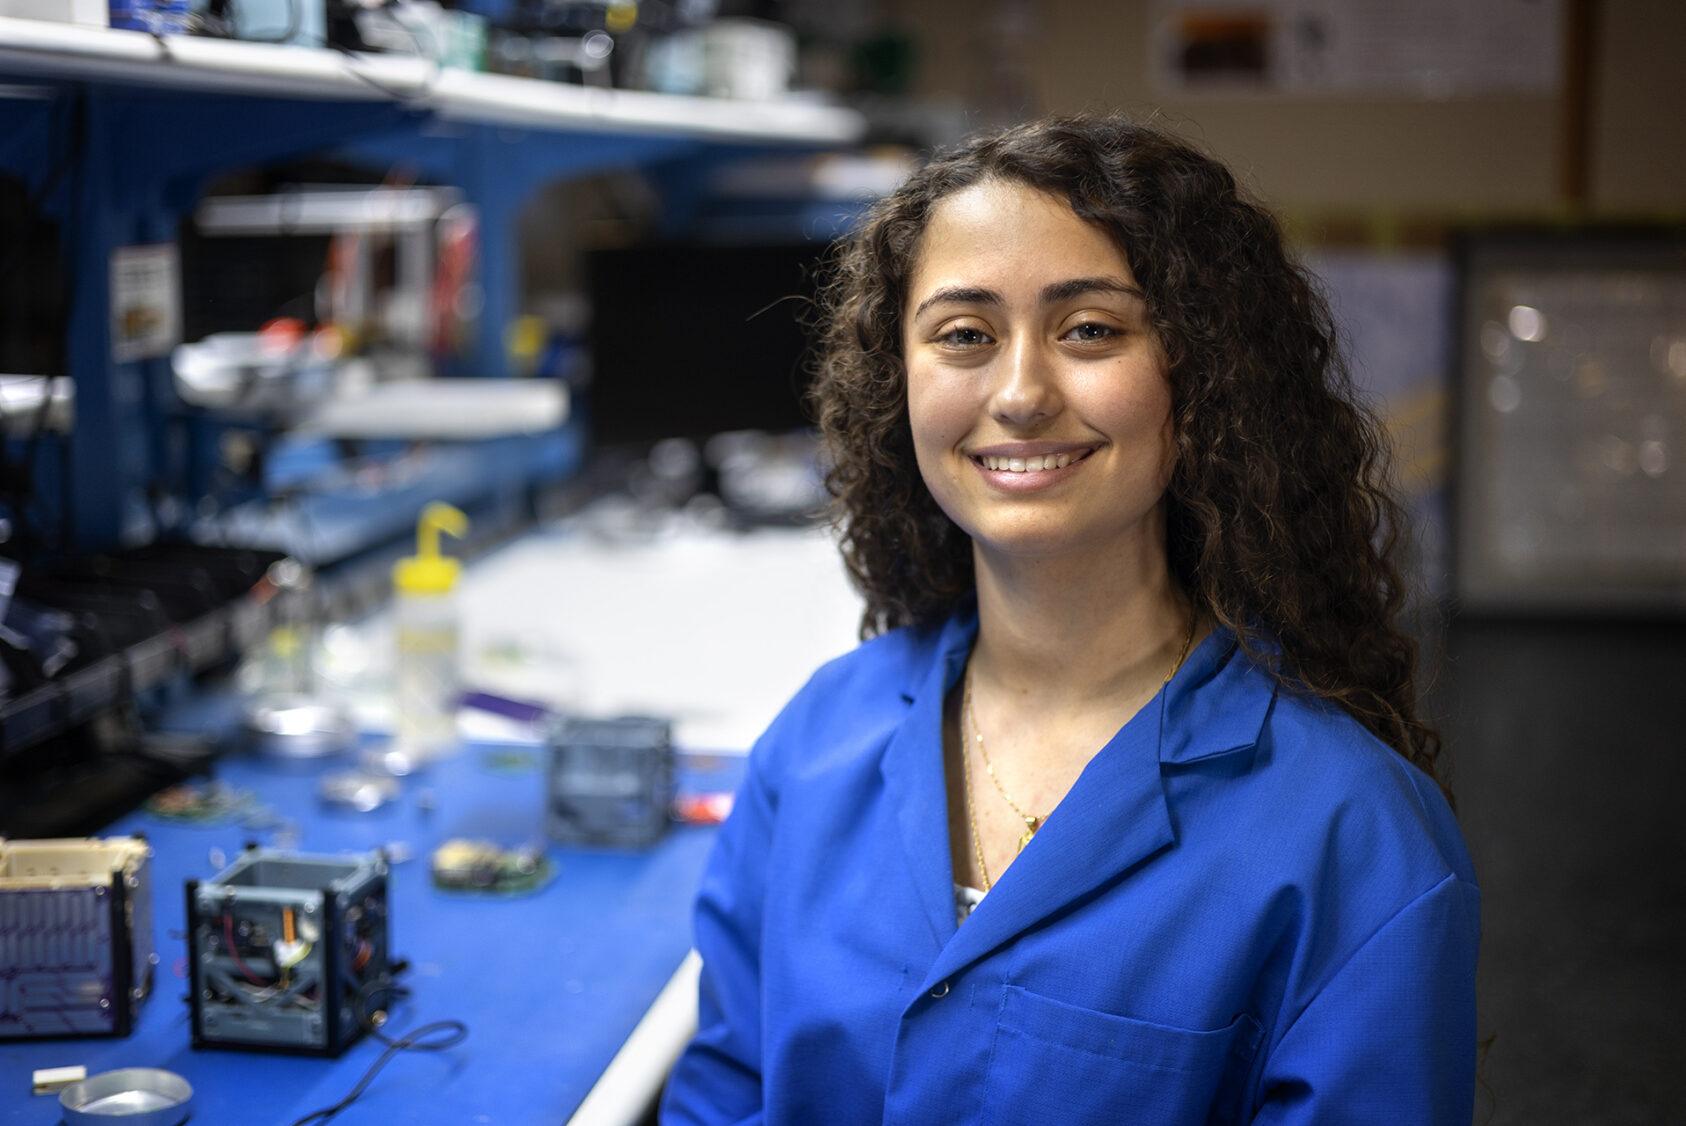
[1453,228,1686,614]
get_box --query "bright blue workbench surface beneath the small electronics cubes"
[0,747,731,1126]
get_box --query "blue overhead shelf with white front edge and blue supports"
[0,19,863,550]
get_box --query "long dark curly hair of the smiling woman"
[811,109,1450,797]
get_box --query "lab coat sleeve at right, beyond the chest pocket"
[1253,875,1480,1126]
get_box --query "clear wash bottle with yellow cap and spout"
[381,502,469,774]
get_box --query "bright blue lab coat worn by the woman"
[663,609,1480,1126]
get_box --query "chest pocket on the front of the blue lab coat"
[985,986,1259,1126]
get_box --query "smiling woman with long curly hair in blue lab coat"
[664,118,1479,1126]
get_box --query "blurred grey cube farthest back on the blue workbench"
[545,716,673,848]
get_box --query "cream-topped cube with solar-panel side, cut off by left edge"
[0,836,158,1042]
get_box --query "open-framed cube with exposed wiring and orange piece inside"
[187,848,391,1055]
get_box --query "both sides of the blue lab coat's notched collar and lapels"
[880,605,1276,986]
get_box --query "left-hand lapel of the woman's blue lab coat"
[878,614,978,952]
